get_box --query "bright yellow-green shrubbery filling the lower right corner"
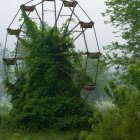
[81,62,140,140]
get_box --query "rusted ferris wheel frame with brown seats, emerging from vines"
[3,0,102,99]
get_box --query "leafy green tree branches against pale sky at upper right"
[103,0,140,72]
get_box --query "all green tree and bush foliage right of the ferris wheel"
[80,0,140,140]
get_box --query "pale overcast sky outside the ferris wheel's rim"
[0,0,121,51]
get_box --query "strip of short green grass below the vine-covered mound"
[0,131,78,140]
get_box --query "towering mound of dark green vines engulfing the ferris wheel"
[5,9,93,130]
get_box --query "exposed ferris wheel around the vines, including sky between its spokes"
[3,0,102,98]
